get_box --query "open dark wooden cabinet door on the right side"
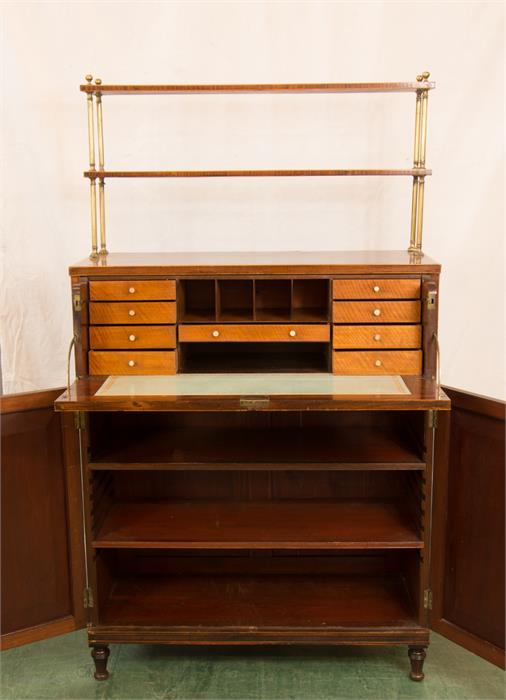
[432,388,505,667]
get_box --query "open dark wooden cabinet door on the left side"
[1,389,84,649]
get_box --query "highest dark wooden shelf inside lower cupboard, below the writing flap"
[90,425,425,470]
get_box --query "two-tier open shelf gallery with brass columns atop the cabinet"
[80,72,435,260]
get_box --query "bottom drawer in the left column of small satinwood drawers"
[88,350,176,375]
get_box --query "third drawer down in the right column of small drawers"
[333,326,422,350]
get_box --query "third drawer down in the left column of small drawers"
[90,326,176,350]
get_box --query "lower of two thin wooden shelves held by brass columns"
[84,168,432,180]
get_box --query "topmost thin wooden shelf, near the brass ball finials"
[80,80,436,95]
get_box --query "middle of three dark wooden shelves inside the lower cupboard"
[93,500,423,550]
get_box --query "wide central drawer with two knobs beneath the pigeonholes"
[179,323,330,343]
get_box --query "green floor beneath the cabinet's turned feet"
[0,631,505,700]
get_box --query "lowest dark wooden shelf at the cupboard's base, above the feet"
[98,574,420,636]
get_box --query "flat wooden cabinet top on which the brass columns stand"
[69,250,441,276]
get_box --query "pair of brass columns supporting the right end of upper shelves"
[408,71,430,255]
